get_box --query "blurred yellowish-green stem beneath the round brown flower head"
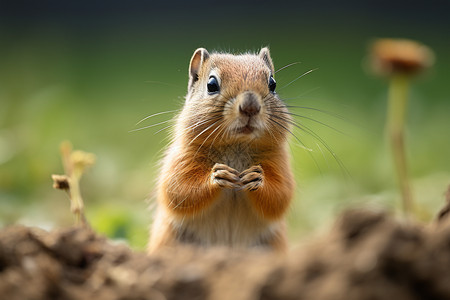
[387,73,414,216]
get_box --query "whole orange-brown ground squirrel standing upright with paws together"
[149,48,294,252]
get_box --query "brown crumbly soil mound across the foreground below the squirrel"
[0,210,450,300]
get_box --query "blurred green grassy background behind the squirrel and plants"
[0,1,450,249]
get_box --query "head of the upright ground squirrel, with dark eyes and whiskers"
[179,48,292,145]
